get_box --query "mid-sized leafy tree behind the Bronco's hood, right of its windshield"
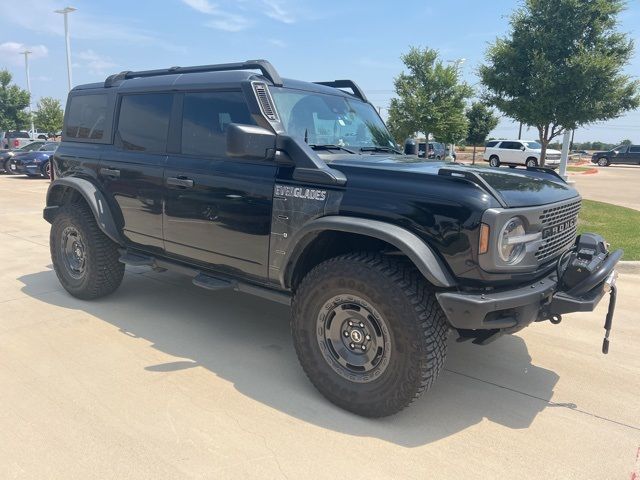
[388,47,473,147]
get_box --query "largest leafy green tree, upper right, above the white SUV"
[479,0,640,165]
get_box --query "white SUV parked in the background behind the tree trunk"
[483,140,561,168]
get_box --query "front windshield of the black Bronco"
[271,87,396,149]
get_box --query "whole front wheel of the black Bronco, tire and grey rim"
[291,253,448,417]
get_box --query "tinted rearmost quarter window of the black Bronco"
[65,95,107,140]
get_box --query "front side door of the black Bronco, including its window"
[164,91,277,281]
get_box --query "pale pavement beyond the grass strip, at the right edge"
[569,165,640,210]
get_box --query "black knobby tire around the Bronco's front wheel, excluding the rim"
[291,253,448,417]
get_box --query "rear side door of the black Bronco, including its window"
[98,92,174,253]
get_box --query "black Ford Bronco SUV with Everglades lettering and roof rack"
[44,60,622,417]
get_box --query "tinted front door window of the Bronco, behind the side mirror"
[182,92,255,156]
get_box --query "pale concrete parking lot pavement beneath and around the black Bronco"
[0,177,640,480]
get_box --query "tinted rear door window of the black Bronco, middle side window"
[116,93,173,152]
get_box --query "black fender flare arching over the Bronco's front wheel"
[280,215,456,288]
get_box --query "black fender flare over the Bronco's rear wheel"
[42,177,124,245]
